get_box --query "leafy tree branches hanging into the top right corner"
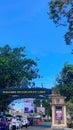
[48,0,73,45]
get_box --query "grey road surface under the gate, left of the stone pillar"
[22,122,51,130]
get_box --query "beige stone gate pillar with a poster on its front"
[52,91,67,129]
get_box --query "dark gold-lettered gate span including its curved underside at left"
[0,87,52,112]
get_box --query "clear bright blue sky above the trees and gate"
[0,0,73,88]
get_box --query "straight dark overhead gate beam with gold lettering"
[0,88,52,98]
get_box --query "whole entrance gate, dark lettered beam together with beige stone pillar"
[0,88,67,129]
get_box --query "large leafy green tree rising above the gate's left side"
[0,45,39,88]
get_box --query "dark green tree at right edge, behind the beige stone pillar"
[56,63,73,101]
